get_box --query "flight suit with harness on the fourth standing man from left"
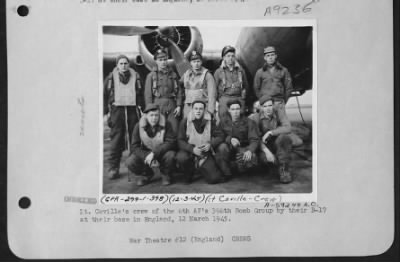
[214,61,249,119]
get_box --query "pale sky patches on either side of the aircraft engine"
[103,26,241,53]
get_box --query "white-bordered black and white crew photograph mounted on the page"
[99,22,316,194]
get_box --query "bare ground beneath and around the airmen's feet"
[103,118,312,194]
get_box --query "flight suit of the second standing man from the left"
[145,68,183,134]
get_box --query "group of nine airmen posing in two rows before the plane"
[104,46,296,186]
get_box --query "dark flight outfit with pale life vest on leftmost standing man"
[103,68,142,172]
